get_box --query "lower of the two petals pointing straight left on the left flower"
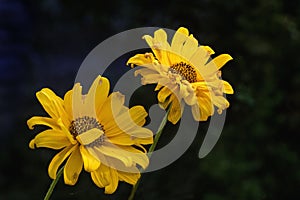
[30,129,71,149]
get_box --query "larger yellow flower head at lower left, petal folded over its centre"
[27,76,153,194]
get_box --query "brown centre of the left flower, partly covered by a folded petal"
[69,116,105,147]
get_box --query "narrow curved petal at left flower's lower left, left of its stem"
[48,145,78,179]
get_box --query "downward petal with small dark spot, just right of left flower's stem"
[64,148,83,185]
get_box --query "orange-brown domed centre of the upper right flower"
[169,62,197,83]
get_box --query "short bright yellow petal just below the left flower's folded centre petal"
[80,145,100,172]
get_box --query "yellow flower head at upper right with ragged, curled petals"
[127,27,233,124]
